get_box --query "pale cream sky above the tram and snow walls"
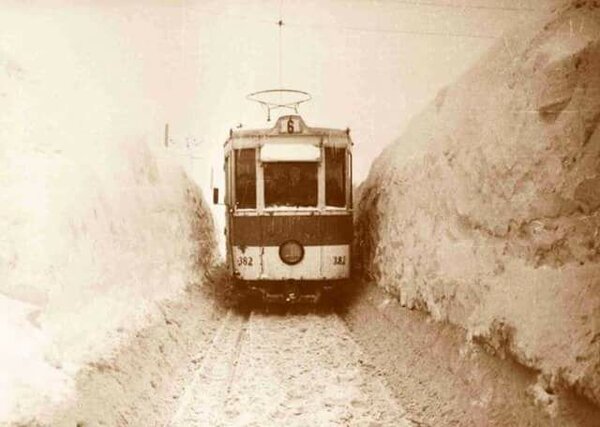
[0,0,549,190]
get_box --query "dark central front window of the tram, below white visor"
[263,162,319,207]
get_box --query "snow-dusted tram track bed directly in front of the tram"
[166,311,414,427]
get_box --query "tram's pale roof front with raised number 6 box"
[224,115,352,151]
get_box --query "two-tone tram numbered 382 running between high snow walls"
[217,96,353,302]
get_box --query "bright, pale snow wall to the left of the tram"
[0,45,215,424]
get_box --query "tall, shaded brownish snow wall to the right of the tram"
[357,1,600,404]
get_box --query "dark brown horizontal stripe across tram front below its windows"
[229,215,352,246]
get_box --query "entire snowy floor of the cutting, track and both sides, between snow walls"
[38,274,600,427]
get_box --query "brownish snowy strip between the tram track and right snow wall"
[342,283,600,427]
